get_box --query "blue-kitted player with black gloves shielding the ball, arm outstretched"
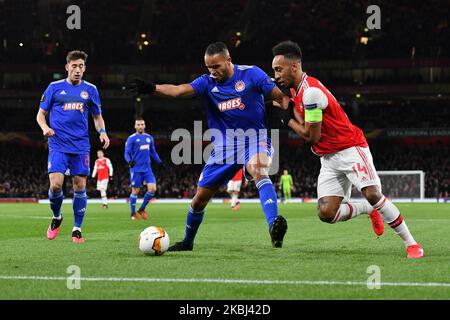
[131,42,289,251]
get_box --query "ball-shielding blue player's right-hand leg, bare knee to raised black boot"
[246,153,287,248]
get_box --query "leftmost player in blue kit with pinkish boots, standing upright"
[36,51,109,243]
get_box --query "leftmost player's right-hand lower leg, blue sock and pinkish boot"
[72,176,87,243]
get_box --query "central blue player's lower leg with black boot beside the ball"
[169,186,220,251]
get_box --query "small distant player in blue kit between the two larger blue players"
[125,117,163,220]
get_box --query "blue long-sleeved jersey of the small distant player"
[125,133,161,172]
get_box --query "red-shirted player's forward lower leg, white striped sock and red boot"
[361,186,424,258]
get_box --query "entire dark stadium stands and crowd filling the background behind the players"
[0,0,450,198]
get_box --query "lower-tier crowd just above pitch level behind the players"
[0,140,450,198]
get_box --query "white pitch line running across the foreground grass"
[0,275,450,287]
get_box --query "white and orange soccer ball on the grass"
[139,226,170,256]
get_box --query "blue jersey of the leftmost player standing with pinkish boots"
[39,79,102,154]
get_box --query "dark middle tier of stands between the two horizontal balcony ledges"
[0,99,450,133]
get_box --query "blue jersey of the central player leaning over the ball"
[190,64,275,146]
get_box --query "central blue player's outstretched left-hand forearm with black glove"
[129,79,195,98]
